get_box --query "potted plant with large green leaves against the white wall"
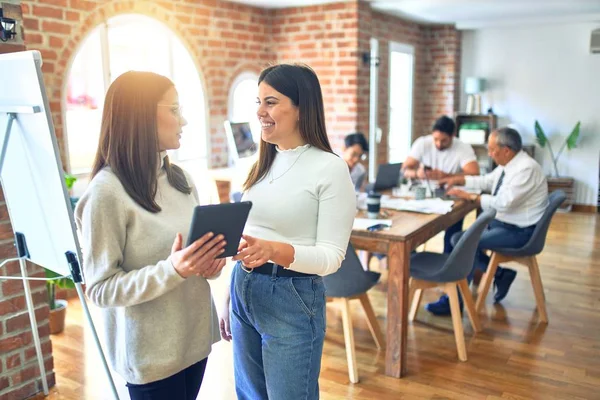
[534,120,581,211]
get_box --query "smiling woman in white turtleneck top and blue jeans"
[221,64,356,400]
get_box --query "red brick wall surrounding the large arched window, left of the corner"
[22,0,273,166]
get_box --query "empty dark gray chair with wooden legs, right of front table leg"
[409,210,496,361]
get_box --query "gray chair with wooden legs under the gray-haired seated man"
[475,190,567,323]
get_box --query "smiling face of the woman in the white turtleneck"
[256,81,303,149]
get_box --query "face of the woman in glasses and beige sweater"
[156,87,187,151]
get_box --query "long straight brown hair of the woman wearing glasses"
[91,71,192,213]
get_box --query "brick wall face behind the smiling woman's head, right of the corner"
[270,2,359,150]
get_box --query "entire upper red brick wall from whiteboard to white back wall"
[22,0,460,166]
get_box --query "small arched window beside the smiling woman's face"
[228,72,260,143]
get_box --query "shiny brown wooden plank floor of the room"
[43,213,600,400]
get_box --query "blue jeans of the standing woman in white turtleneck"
[230,263,325,400]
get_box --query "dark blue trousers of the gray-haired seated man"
[450,219,535,282]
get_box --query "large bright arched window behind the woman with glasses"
[65,14,208,174]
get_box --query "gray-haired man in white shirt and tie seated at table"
[425,128,548,315]
